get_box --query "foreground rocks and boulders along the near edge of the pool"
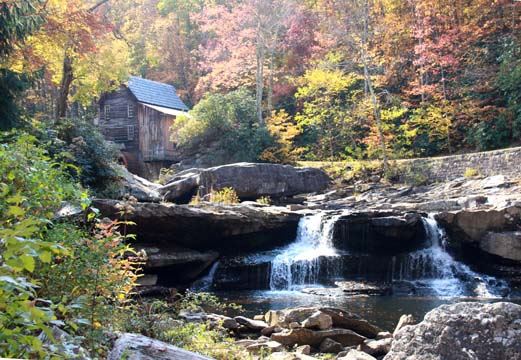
[109,302,521,360]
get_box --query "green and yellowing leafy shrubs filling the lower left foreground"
[0,134,140,358]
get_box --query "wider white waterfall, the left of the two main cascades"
[270,213,340,290]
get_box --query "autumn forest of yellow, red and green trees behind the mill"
[0,0,521,162]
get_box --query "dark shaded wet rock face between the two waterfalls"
[333,213,427,255]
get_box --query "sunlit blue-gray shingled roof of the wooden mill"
[128,76,188,111]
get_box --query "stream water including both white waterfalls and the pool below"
[192,212,521,330]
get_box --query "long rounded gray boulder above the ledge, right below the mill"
[159,163,330,201]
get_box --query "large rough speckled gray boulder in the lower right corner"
[384,302,521,360]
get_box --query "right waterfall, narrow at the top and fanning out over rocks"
[393,216,497,298]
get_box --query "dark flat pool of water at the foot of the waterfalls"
[215,291,521,332]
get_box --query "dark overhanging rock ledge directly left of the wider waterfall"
[93,200,300,251]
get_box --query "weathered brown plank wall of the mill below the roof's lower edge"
[137,103,175,161]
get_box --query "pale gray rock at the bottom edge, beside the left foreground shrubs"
[107,333,212,360]
